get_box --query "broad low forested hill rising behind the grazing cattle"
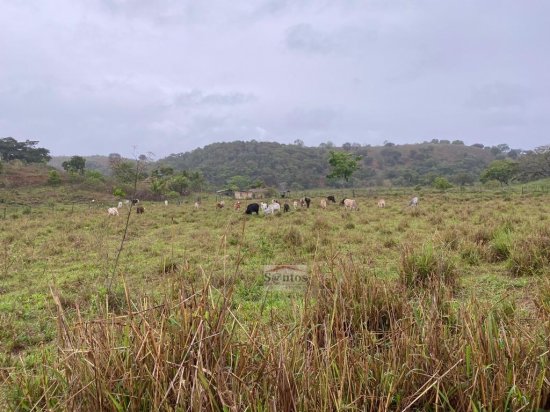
[158,141,508,189]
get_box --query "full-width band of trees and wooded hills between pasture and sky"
[0,137,550,192]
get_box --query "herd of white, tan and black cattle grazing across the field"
[107,195,418,216]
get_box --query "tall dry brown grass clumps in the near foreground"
[8,256,550,411]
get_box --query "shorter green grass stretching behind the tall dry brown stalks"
[0,189,550,409]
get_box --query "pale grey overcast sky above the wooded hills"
[0,0,550,158]
